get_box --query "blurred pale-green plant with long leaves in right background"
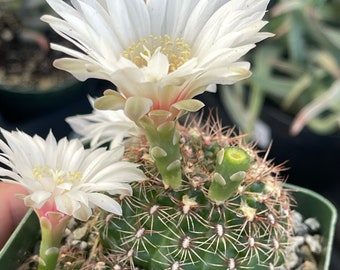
[220,0,340,143]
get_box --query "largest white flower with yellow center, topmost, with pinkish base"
[42,0,270,122]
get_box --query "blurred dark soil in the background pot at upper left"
[0,10,71,91]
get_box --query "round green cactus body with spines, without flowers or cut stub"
[101,123,291,270]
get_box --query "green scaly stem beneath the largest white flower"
[143,121,182,189]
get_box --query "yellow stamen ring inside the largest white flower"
[123,35,191,73]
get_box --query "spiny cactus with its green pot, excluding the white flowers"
[0,115,336,270]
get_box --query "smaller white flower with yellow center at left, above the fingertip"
[0,130,145,221]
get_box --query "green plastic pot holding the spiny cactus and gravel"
[0,184,337,270]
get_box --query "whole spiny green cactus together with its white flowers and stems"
[0,0,336,270]
